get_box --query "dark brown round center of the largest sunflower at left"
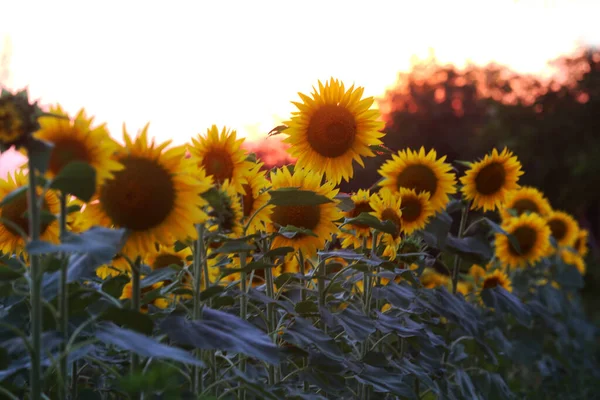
[100,156,176,231]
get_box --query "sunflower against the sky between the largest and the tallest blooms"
[189,125,252,194]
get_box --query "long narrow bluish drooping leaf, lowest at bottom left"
[95,323,204,367]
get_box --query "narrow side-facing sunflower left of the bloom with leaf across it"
[242,163,273,235]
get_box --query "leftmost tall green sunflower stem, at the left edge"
[27,159,43,400]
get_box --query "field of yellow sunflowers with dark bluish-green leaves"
[0,79,600,400]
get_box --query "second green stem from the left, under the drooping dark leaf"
[58,193,69,398]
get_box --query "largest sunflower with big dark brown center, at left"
[84,125,212,259]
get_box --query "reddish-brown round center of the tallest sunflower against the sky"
[307,104,356,158]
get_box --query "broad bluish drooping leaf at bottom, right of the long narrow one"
[160,307,279,364]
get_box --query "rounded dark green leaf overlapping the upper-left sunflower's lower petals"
[50,161,96,201]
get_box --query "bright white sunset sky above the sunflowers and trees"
[0,0,600,176]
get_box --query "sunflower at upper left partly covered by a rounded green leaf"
[34,105,124,185]
